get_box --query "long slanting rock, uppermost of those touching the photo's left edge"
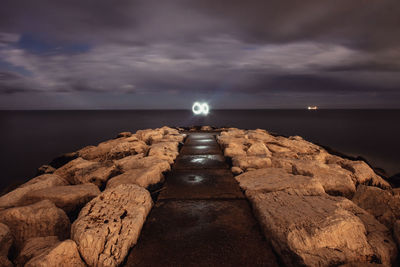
[0,174,68,208]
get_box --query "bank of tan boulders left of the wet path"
[0,127,185,266]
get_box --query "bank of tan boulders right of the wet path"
[218,129,400,266]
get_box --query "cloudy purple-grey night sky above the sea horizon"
[0,0,400,109]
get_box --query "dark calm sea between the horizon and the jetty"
[0,110,400,192]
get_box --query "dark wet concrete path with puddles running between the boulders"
[126,132,278,266]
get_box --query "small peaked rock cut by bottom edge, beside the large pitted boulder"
[25,240,86,267]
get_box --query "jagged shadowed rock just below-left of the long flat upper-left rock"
[55,158,119,187]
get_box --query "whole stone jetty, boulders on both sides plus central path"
[0,127,400,266]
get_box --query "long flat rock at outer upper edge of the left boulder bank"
[78,139,148,161]
